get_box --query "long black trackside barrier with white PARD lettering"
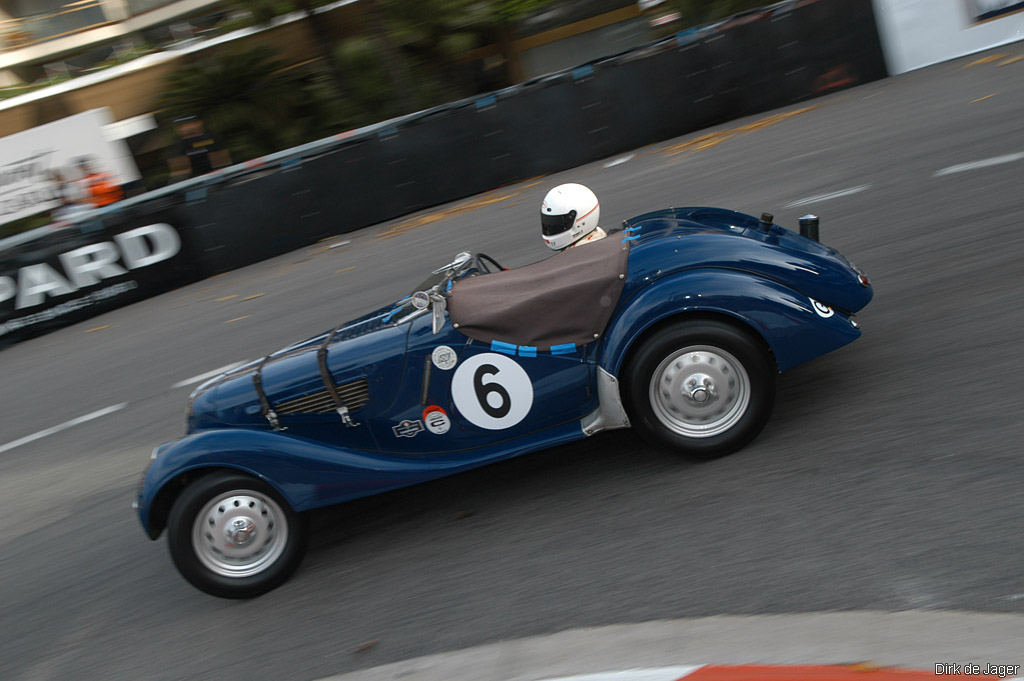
[0,0,887,344]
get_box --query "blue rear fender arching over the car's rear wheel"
[598,268,860,376]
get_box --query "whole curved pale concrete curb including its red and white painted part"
[321,610,1024,681]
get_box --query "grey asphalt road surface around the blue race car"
[0,43,1024,681]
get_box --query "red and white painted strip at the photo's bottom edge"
[544,664,1019,681]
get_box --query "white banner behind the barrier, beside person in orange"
[0,109,139,224]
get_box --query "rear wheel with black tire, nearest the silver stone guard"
[623,320,778,460]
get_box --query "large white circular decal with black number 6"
[452,352,534,430]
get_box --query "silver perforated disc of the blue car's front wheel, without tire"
[193,490,288,578]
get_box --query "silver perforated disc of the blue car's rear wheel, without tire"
[649,345,751,437]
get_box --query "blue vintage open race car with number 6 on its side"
[136,208,871,597]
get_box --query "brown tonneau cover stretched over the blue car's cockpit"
[447,235,629,348]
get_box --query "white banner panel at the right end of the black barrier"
[873,0,1024,76]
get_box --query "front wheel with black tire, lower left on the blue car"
[167,472,308,598]
